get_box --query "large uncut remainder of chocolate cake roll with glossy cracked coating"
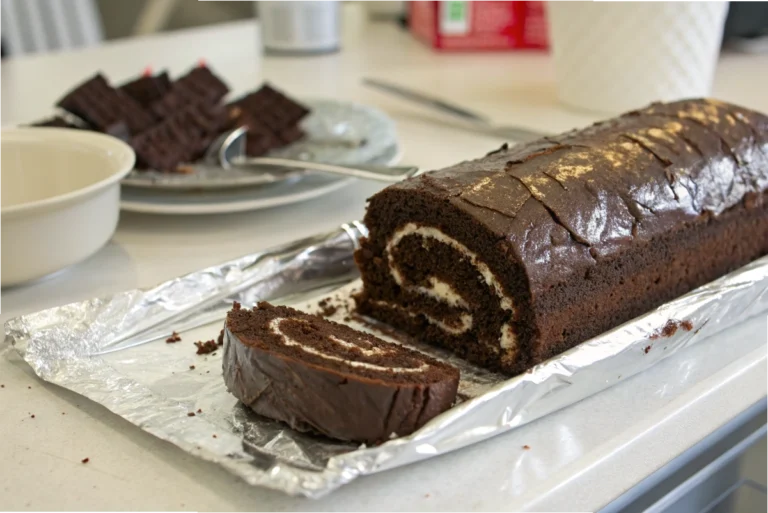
[356,100,768,374]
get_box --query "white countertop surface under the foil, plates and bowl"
[0,14,768,513]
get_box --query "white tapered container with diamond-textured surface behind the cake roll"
[548,0,728,114]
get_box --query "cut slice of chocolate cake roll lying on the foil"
[223,303,459,443]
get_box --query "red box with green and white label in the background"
[409,0,548,50]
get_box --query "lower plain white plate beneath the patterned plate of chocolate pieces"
[121,145,402,214]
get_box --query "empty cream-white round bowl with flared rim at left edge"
[0,128,136,287]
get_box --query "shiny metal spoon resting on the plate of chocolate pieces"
[205,127,419,182]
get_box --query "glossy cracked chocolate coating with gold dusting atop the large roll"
[384,99,768,290]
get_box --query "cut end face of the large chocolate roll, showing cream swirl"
[355,178,534,374]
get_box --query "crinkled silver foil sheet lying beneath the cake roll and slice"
[5,223,768,497]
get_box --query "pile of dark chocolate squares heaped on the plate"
[35,64,309,172]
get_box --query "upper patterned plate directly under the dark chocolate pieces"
[122,100,397,191]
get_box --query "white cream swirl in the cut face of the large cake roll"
[386,223,517,349]
